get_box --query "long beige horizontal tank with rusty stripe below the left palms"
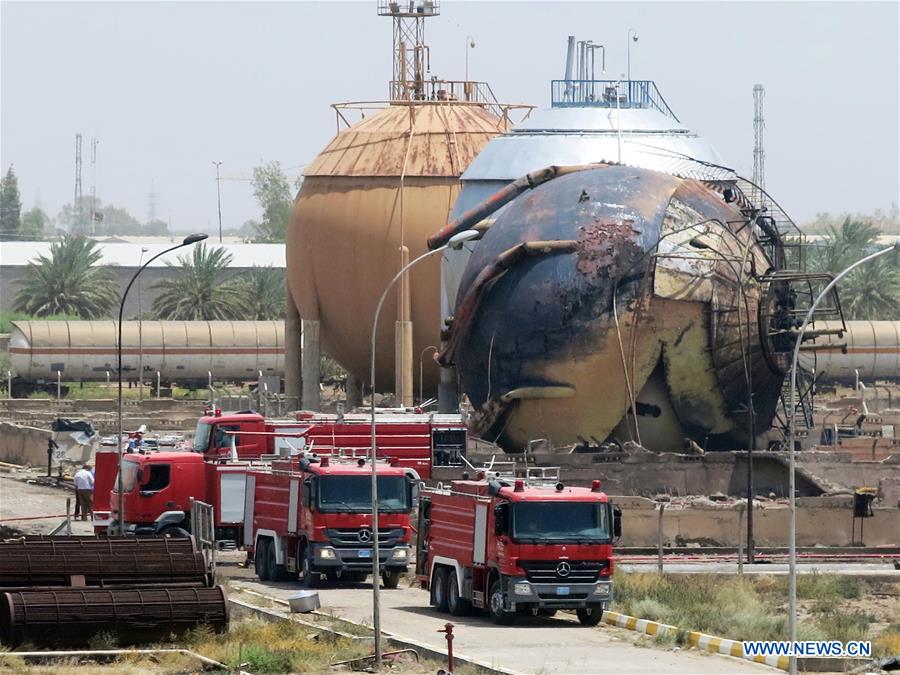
[9,321,284,382]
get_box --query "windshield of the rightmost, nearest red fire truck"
[512,502,610,543]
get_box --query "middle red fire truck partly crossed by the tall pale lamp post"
[244,455,419,588]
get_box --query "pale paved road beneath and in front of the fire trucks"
[232,570,778,675]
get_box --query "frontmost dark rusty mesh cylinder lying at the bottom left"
[0,586,229,646]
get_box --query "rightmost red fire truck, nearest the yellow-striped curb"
[416,478,621,626]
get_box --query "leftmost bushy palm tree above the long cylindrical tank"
[14,236,119,319]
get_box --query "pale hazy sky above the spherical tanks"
[0,0,900,232]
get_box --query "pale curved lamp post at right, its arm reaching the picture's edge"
[788,237,900,675]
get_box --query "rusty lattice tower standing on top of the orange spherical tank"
[378,0,441,101]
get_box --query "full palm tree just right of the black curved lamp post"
[153,243,247,321]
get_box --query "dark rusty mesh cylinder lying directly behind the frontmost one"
[0,550,210,587]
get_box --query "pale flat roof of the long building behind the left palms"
[0,239,285,269]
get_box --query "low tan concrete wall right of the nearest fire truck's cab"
[612,496,900,546]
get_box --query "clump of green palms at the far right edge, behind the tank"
[806,217,900,320]
